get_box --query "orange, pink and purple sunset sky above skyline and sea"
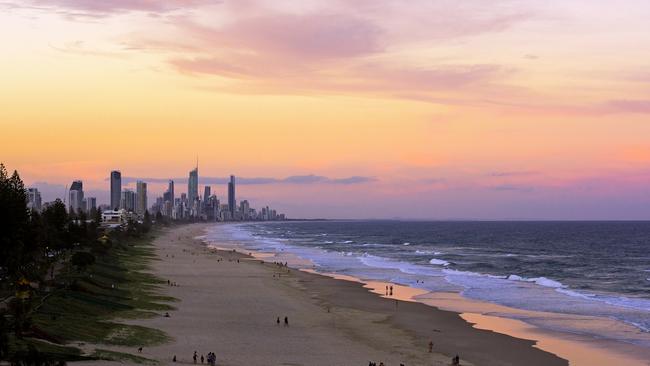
[0,0,650,220]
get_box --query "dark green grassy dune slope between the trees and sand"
[25,230,175,354]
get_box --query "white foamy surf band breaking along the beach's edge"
[205,225,650,348]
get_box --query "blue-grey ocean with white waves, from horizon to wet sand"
[207,221,650,348]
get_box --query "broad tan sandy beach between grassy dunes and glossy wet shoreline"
[72,224,567,366]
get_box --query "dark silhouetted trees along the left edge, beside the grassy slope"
[0,163,154,360]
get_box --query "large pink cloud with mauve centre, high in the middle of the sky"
[169,10,513,100]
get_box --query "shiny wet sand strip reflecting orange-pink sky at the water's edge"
[206,222,650,366]
